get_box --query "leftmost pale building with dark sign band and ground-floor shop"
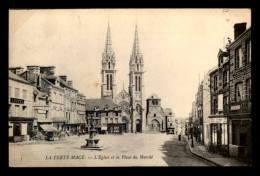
[8,71,35,142]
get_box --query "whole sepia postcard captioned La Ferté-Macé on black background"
[8,9,252,167]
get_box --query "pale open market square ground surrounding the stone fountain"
[9,133,207,167]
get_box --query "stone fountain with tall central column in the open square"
[81,116,105,150]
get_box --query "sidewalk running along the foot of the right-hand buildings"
[183,136,248,167]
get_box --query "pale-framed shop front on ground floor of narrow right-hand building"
[209,117,229,155]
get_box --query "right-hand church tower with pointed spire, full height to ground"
[129,25,146,132]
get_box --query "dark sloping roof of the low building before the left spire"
[86,98,118,111]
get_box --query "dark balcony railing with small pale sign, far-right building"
[223,100,251,115]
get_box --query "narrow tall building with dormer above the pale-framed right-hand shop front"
[209,48,229,155]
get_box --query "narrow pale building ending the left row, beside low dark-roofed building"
[76,93,87,133]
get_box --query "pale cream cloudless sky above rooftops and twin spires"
[9,9,251,118]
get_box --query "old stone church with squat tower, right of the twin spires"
[146,94,167,132]
